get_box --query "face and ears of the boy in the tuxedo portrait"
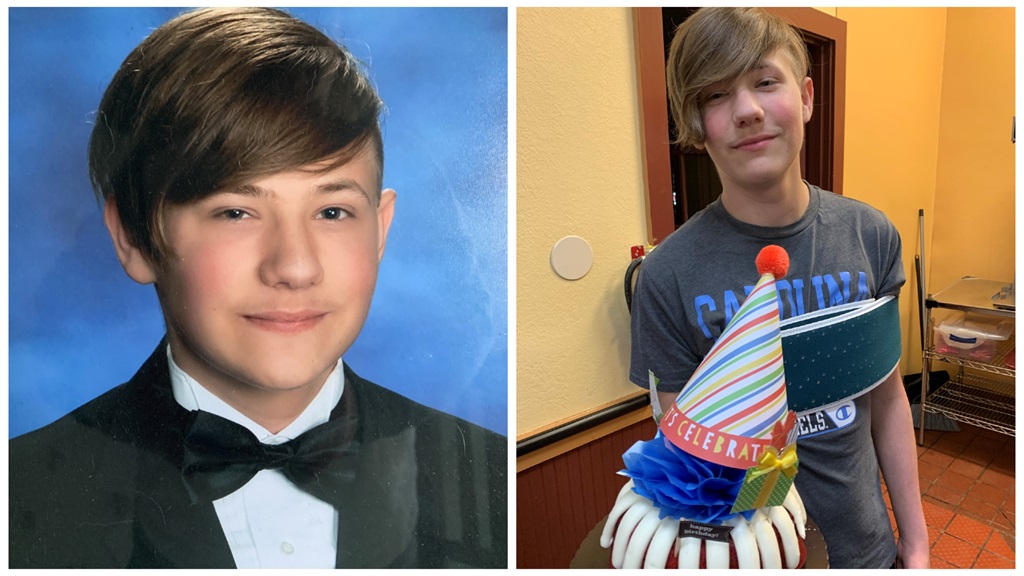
[108,145,395,402]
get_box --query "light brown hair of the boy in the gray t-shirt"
[666,7,810,146]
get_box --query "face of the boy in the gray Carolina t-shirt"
[700,50,813,189]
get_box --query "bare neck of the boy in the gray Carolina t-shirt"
[722,172,811,228]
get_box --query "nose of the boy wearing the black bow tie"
[259,218,324,289]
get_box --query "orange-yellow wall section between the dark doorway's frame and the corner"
[837,8,946,373]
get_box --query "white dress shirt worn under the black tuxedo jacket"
[167,345,345,568]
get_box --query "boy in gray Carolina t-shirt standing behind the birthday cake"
[630,8,929,568]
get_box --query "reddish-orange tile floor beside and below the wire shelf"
[883,423,1017,568]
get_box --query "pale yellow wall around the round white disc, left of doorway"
[516,8,646,434]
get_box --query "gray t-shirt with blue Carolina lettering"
[630,184,906,568]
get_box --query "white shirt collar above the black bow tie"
[167,344,345,444]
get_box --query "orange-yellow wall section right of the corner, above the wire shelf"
[926,8,1018,292]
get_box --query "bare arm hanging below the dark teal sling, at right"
[870,367,929,568]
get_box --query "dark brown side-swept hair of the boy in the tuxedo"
[89,8,384,263]
